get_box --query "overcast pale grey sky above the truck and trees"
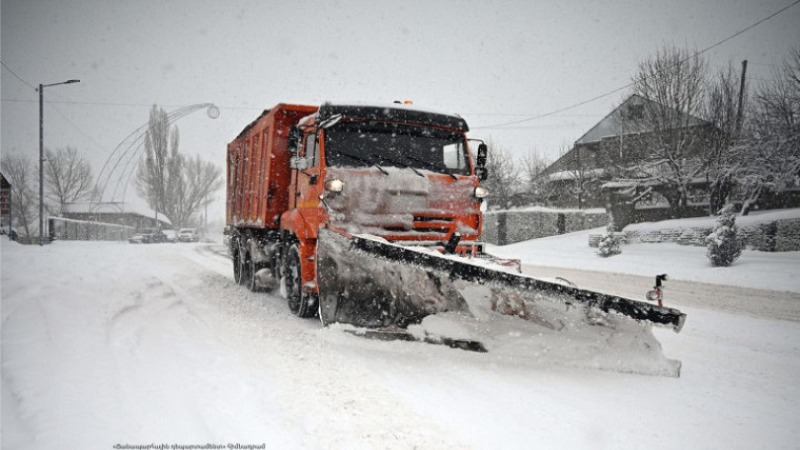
[0,0,800,217]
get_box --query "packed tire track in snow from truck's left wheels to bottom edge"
[166,244,469,449]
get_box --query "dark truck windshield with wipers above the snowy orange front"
[325,123,469,175]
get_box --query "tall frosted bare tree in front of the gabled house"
[630,47,707,213]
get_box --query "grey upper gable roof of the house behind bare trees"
[575,94,707,145]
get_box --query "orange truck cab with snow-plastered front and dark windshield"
[281,104,487,253]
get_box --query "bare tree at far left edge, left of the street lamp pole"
[0,153,39,236]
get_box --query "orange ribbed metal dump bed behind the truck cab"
[226,104,319,229]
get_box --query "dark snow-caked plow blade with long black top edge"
[318,229,686,332]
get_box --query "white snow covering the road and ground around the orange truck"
[0,230,800,449]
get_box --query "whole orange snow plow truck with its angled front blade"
[225,102,685,350]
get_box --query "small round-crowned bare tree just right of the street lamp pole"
[44,147,92,214]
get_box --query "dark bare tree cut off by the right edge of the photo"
[737,47,800,215]
